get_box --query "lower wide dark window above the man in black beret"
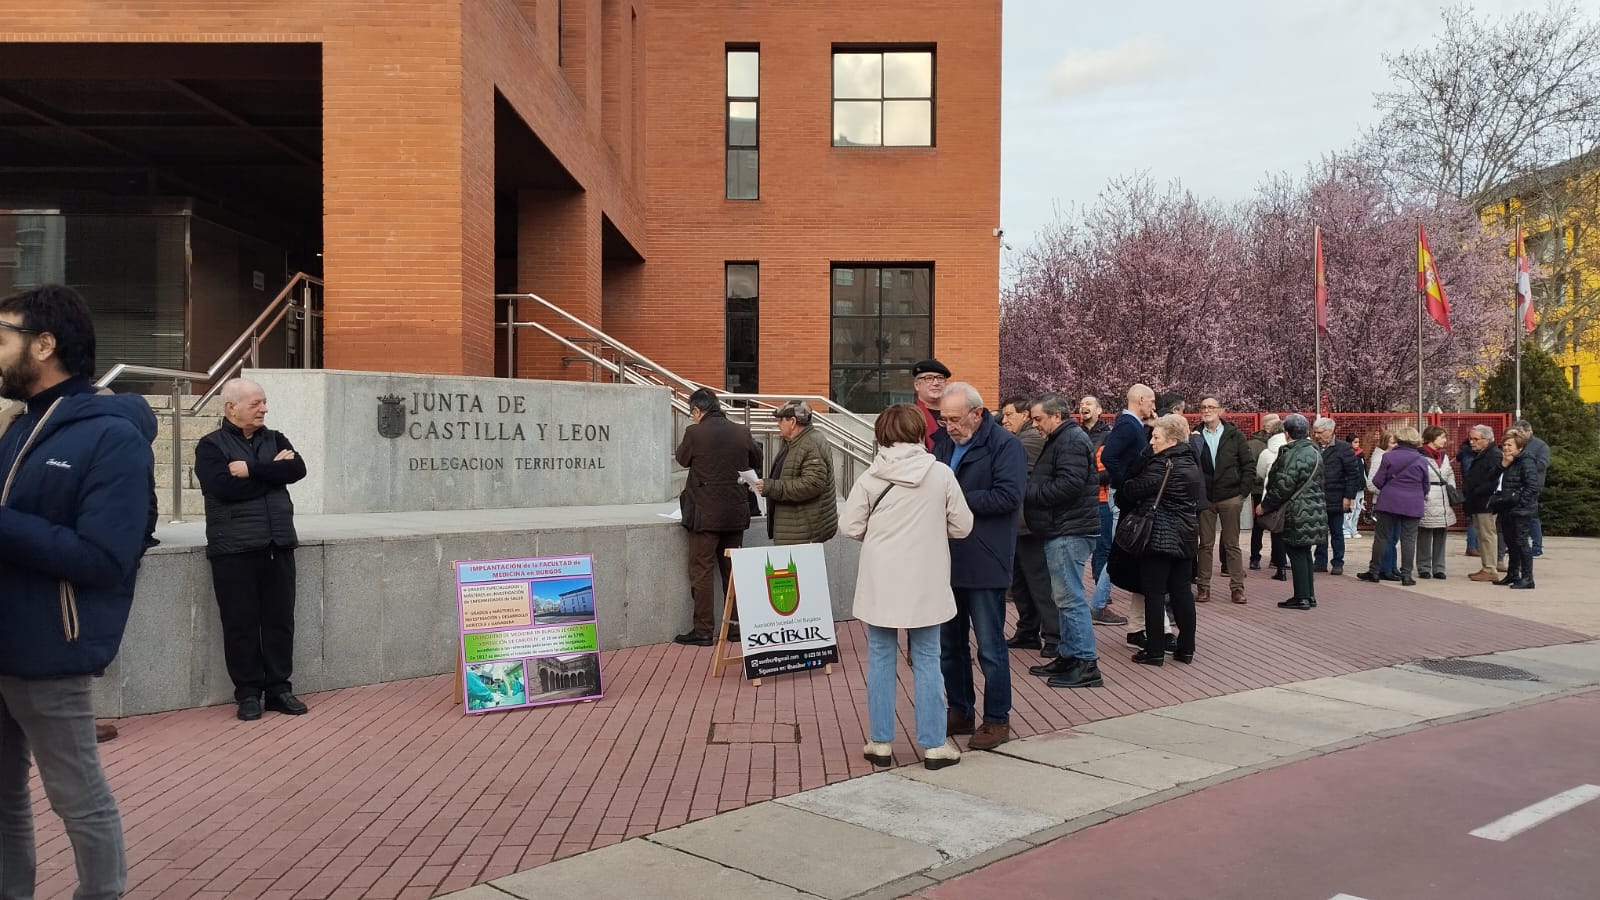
[829,263,933,413]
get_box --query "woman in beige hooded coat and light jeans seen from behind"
[838,404,973,769]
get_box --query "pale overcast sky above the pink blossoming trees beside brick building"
[1000,0,1555,248]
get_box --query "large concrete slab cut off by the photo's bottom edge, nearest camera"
[483,839,813,900]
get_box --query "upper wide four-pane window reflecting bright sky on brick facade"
[834,50,933,147]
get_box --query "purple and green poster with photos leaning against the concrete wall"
[456,554,602,713]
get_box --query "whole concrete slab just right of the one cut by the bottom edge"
[650,802,944,900]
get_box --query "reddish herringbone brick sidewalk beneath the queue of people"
[35,578,1586,900]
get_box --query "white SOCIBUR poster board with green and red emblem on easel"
[733,544,838,679]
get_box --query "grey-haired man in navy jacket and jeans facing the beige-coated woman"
[933,381,1027,749]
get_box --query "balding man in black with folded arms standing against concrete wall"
[195,378,306,722]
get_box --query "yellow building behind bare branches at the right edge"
[1478,149,1600,404]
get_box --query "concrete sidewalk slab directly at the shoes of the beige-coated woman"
[894,745,1152,822]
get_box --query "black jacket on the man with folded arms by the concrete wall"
[195,420,306,556]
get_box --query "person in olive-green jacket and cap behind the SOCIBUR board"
[755,400,838,544]
